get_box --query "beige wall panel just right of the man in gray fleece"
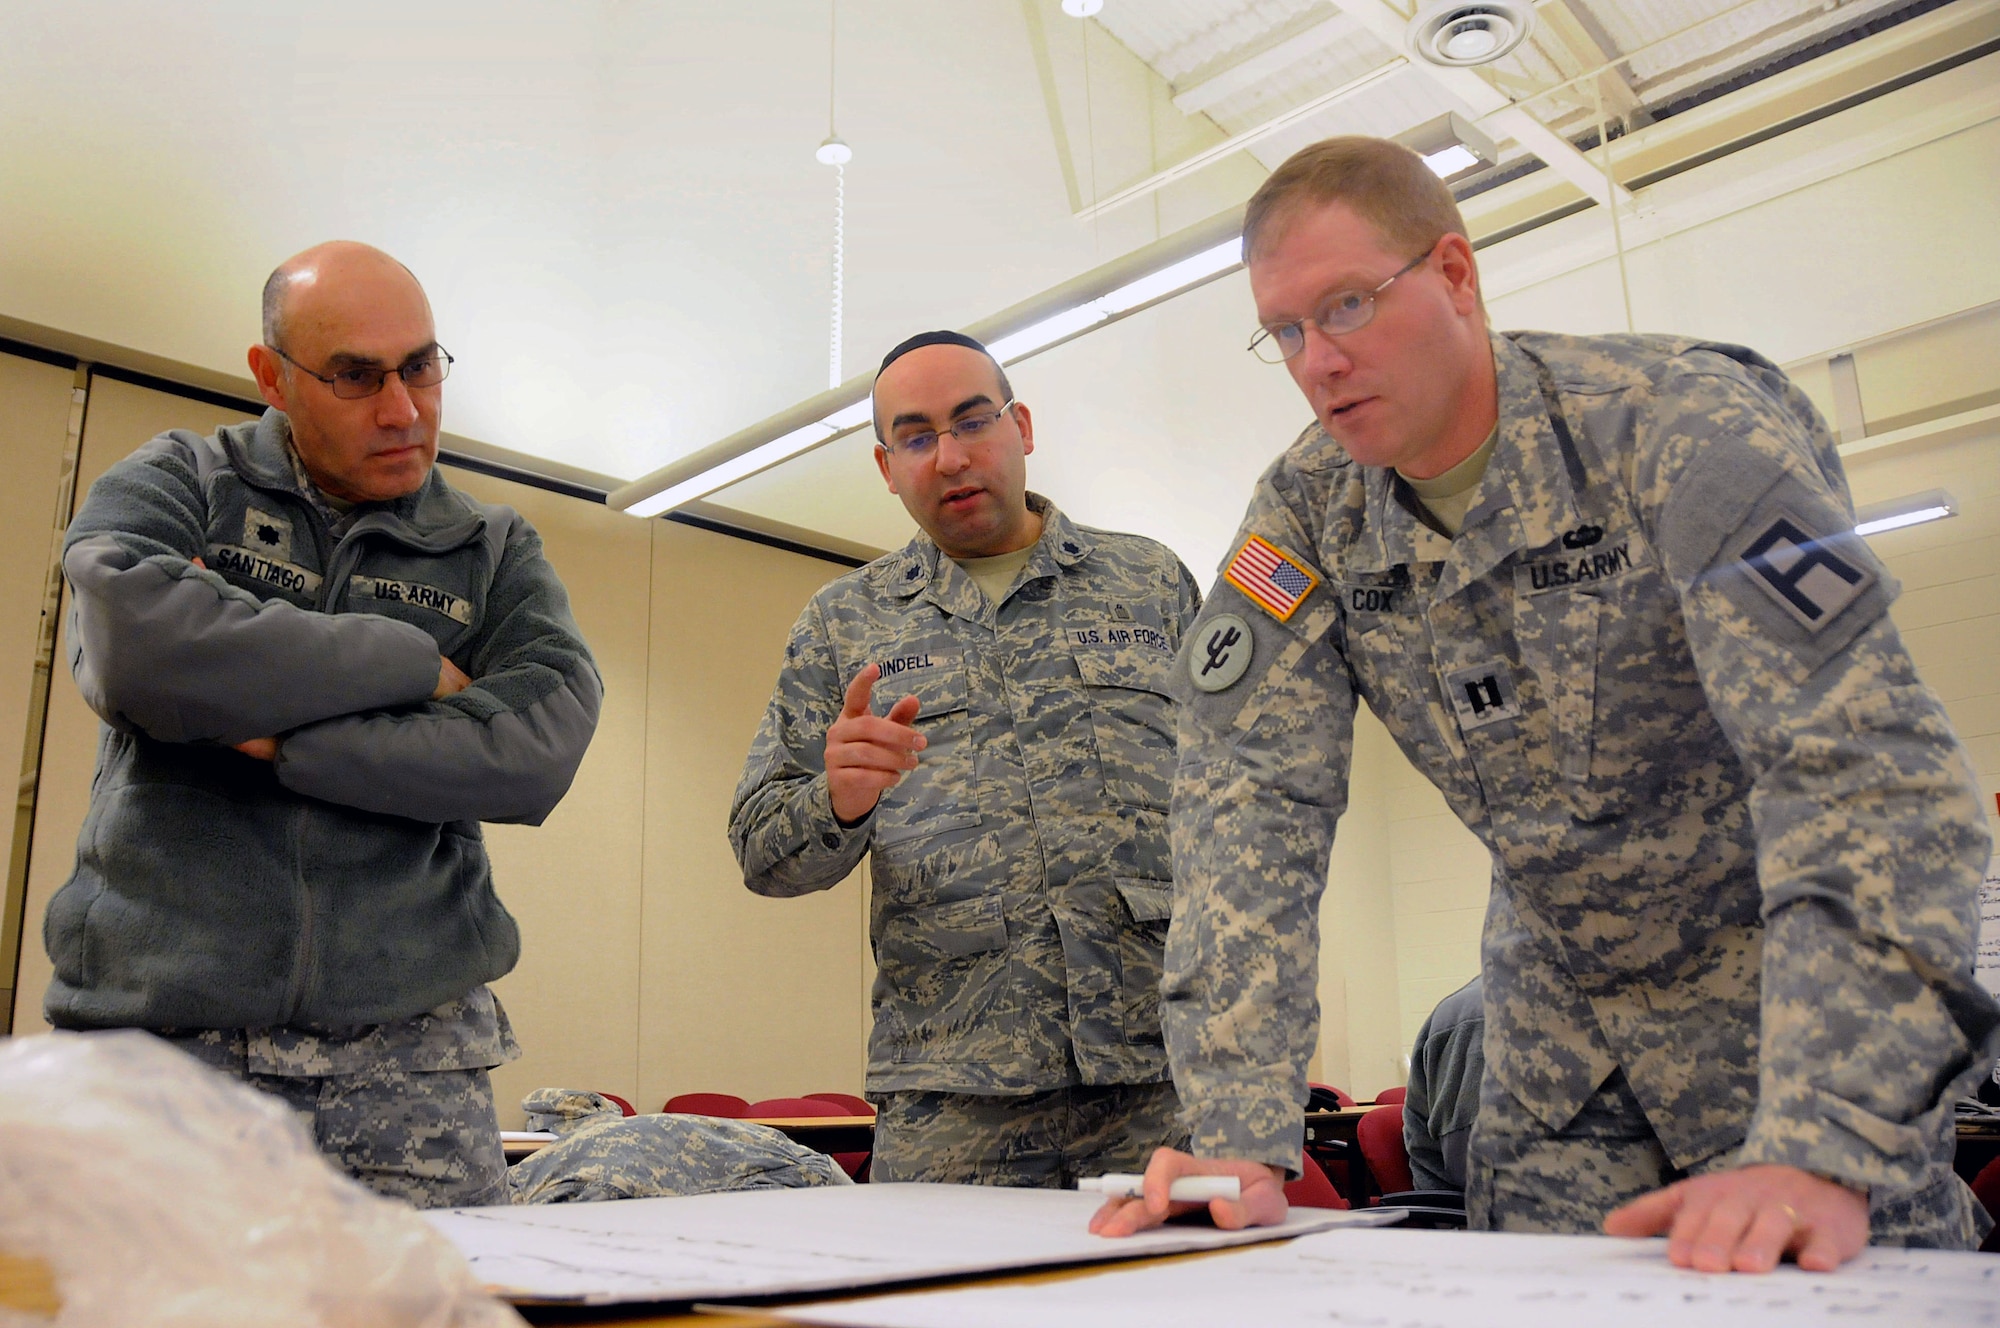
[444,468,658,1130]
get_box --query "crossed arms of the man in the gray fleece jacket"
[64,446,602,822]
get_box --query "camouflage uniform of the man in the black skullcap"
[730,494,1200,1184]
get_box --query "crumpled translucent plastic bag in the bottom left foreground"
[0,1032,522,1328]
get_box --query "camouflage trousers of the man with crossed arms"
[162,986,520,1208]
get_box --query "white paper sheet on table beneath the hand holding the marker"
[424,1184,1402,1304]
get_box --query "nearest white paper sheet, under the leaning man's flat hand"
[766,1228,2000,1328]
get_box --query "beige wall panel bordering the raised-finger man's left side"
[636,522,864,1110]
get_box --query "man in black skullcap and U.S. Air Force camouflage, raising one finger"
[730,332,1200,1186]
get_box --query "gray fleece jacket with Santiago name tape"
[44,410,602,1030]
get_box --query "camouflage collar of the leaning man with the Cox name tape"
[1344,332,1578,594]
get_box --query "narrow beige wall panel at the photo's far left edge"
[0,354,76,1018]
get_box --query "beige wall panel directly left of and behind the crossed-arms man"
[14,378,246,1032]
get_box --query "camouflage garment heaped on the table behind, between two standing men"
[506,1088,854,1204]
